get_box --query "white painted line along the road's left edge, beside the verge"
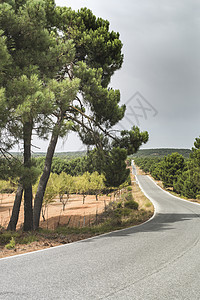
[0,175,157,261]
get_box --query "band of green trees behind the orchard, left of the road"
[35,149,130,187]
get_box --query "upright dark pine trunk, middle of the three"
[23,122,33,231]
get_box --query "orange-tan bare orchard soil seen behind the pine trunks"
[0,194,112,229]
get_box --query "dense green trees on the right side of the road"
[134,138,200,199]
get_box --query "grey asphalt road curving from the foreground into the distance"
[0,176,200,300]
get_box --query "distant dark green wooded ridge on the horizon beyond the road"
[131,148,191,158]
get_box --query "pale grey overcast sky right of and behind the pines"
[29,0,200,151]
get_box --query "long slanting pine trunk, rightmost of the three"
[33,118,62,230]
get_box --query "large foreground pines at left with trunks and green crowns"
[0,0,148,231]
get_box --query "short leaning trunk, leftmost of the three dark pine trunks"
[7,183,23,231]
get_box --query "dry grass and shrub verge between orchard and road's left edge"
[0,171,154,257]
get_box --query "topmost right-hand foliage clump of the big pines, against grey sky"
[55,7,123,87]
